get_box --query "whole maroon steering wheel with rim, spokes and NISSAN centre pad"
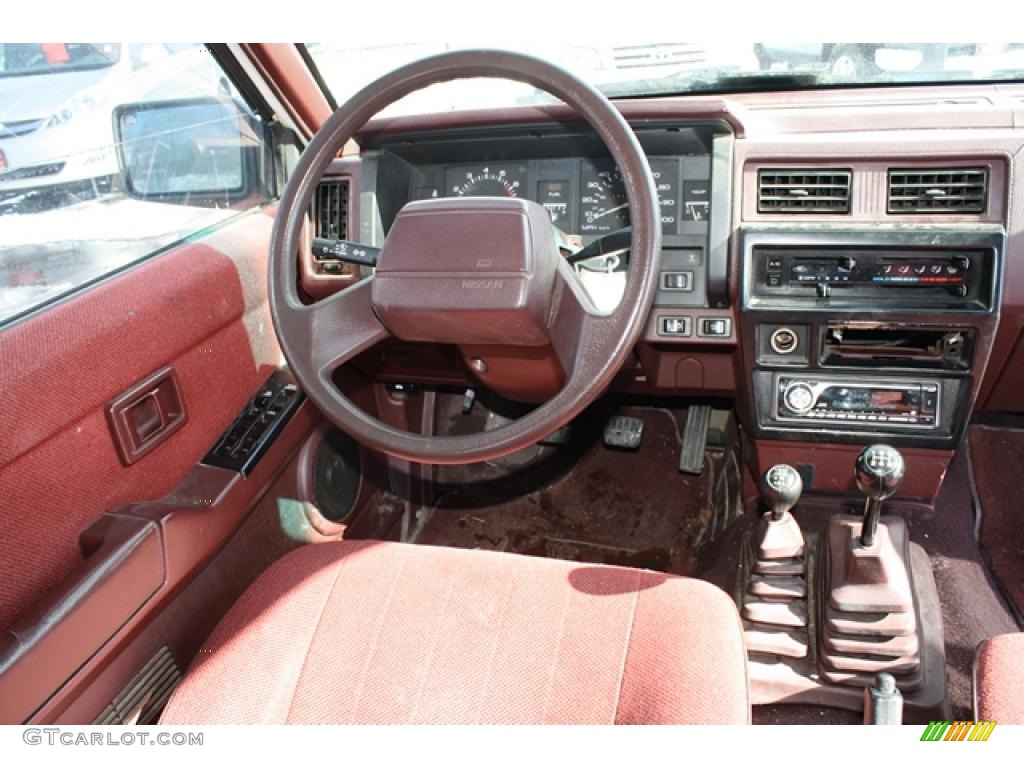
[269,50,662,464]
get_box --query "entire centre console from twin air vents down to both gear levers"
[736,163,1007,722]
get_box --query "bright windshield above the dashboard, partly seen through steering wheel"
[306,43,1024,115]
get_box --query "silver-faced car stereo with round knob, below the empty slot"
[773,375,942,430]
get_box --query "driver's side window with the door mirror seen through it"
[0,43,267,325]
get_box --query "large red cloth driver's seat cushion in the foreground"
[162,542,751,724]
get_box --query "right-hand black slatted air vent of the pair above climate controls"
[889,168,988,213]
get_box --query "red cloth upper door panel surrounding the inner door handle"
[0,211,280,630]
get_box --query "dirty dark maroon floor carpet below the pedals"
[407,408,729,575]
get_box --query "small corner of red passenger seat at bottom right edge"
[974,632,1024,725]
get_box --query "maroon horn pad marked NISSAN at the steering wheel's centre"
[371,198,561,346]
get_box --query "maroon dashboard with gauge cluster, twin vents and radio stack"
[307,93,1024,479]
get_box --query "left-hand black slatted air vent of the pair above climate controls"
[758,168,853,213]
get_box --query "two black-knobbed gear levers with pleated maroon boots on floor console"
[735,443,949,724]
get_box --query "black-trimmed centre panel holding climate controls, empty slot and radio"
[741,225,1005,450]
